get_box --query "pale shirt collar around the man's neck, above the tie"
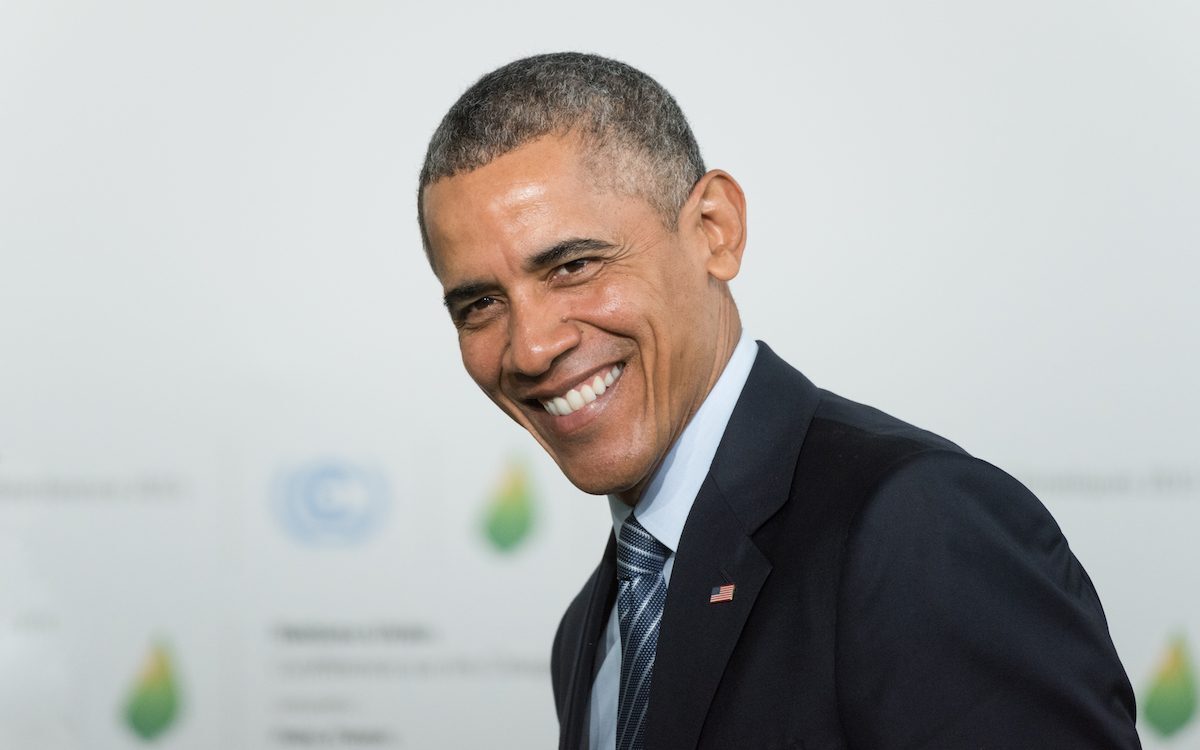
[608,330,758,552]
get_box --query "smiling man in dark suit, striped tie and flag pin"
[419,54,1139,750]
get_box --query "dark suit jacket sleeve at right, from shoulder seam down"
[835,450,1140,750]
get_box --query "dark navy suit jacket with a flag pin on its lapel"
[551,343,1139,750]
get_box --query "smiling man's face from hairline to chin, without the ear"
[425,136,737,502]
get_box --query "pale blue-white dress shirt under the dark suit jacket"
[588,330,758,750]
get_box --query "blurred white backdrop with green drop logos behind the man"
[0,0,1200,749]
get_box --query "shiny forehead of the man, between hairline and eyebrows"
[424,136,648,282]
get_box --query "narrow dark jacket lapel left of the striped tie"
[562,534,617,750]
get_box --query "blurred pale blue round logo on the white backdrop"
[276,461,390,546]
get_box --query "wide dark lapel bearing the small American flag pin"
[646,342,818,748]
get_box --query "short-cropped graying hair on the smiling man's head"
[416,52,704,260]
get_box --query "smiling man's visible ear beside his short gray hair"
[679,169,746,281]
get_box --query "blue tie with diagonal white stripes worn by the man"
[617,514,671,750]
